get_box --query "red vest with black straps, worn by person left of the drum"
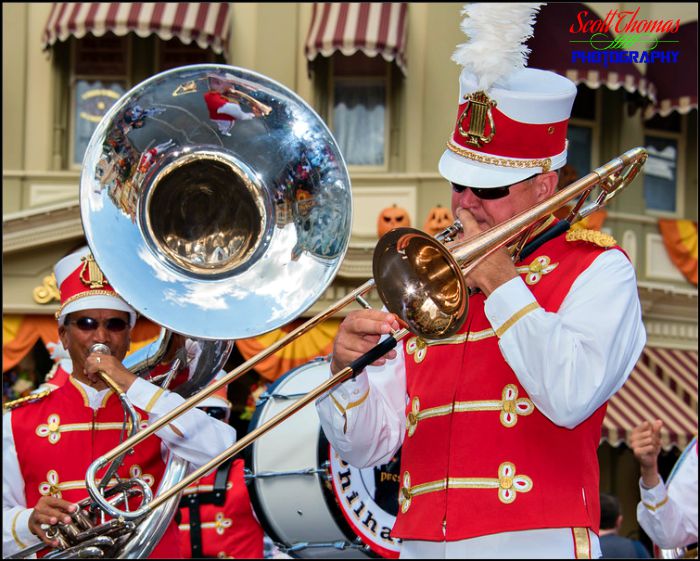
[180,460,263,559]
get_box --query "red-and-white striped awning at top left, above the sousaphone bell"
[42,2,229,54]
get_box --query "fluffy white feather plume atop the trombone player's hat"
[452,2,544,91]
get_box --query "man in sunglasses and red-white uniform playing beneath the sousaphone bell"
[3,247,236,558]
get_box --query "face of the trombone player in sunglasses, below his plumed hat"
[452,172,556,231]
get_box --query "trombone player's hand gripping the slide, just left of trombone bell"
[331,310,399,374]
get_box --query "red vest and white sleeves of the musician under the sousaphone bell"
[3,377,236,558]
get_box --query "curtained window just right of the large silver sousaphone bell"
[329,53,390,169]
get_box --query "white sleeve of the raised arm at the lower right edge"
[637,444,698,549]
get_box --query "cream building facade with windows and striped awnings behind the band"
[2,3,698,548]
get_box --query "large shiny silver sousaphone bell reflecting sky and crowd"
[81,65,352,339]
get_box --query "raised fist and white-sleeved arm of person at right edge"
[630,419,698,556]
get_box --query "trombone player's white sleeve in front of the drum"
[316,341,406,468]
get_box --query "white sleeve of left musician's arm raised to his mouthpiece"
[126,378,241,468]
